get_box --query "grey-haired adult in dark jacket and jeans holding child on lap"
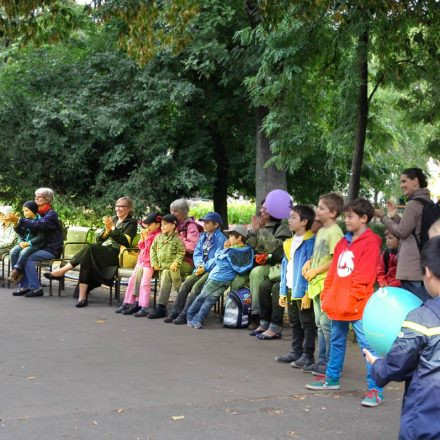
[8,188,63,297]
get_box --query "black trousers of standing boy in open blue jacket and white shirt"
[289,298,316,359]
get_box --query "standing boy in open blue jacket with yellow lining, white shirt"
[275,205,316,368]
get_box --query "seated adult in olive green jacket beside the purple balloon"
[231,201,292,330]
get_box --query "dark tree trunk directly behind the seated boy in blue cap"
[213,133,229,229]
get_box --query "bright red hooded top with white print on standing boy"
[321,229,382,321]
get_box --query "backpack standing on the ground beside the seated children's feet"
[223,287,252,328]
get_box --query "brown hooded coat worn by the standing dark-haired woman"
[381,188,431,281]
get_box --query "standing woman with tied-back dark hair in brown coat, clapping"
[375,168,431,302]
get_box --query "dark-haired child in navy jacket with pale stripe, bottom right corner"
[363,237,440,440]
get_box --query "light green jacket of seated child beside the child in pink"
[150,233,185,270]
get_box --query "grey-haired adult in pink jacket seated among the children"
[148,199,200,319]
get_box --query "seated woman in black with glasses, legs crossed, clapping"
[44,197,137,307]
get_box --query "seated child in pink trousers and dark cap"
[115,212,162,318]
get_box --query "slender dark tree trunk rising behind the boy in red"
[348,29,368,200]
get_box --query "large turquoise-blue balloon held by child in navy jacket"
[362,287,422,356]
